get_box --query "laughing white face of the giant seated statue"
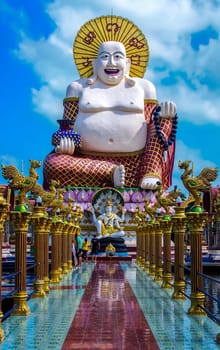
[94,41,129,85]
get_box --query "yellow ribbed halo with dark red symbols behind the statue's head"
[73,16,149,78]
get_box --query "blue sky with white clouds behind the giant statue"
[0,0,220,193]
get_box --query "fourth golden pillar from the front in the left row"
[50,219,63,283]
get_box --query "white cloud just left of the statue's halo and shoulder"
[16,29,76,120]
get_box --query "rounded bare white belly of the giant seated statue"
[74,110,147,152]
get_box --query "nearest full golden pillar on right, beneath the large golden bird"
[186,212,207,316]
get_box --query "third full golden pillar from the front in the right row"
[160,216,172,288]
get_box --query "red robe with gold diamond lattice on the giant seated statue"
[44,98,175,189]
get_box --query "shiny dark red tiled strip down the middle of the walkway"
[62,262,159,350]
